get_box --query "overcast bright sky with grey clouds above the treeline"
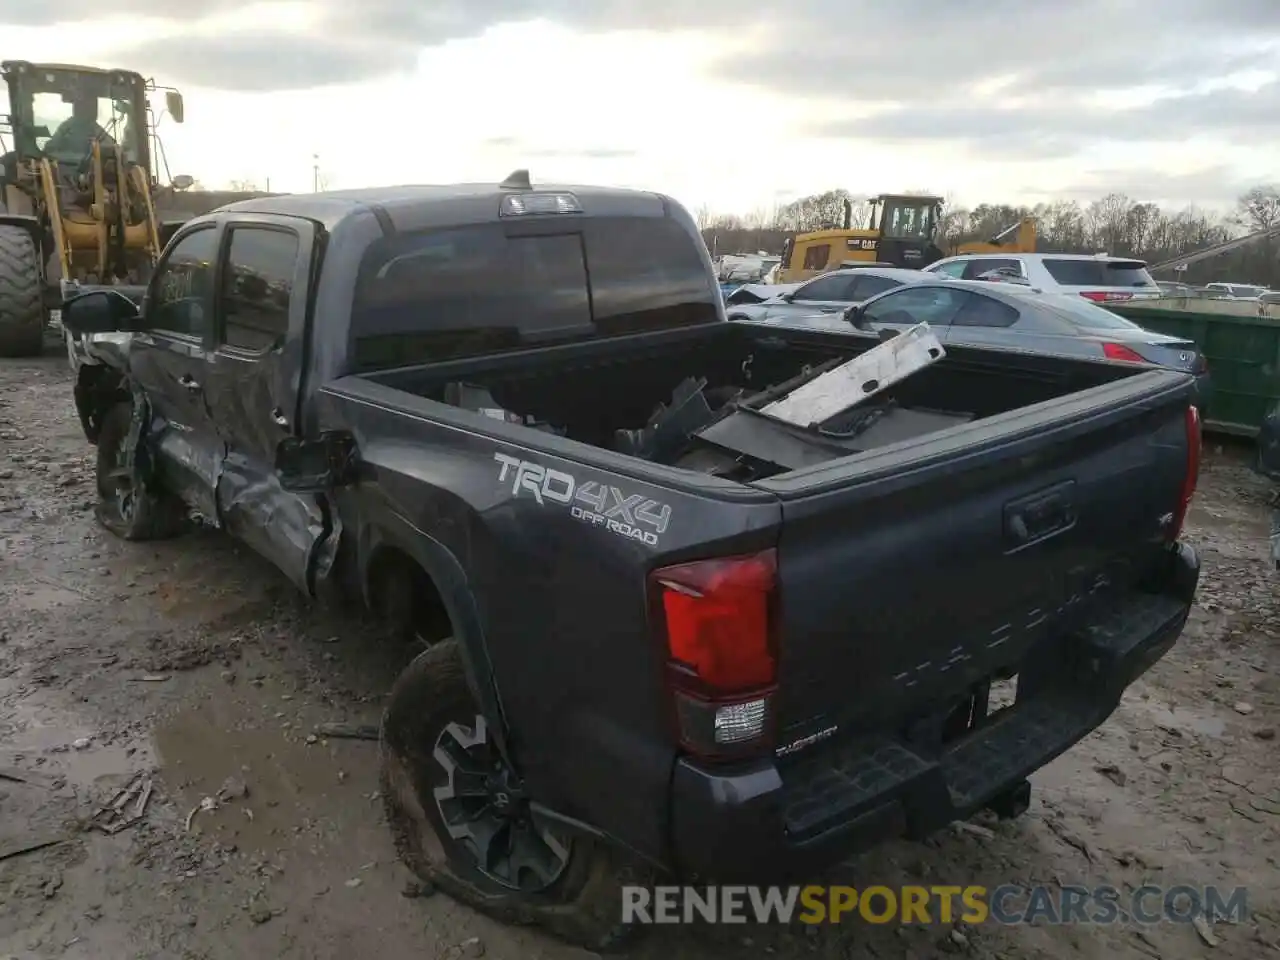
[0,0,1280,212]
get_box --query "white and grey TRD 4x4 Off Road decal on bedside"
[493,453,671,547]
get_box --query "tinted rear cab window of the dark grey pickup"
[351,216,721,371]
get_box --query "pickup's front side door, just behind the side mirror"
[129,224,223,522]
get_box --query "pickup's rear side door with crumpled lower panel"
[199,214,324,593]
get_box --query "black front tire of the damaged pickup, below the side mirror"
[96,402,187,540]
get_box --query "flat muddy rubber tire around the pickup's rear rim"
[380,639,652,951]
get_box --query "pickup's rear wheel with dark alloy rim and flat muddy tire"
[381,639,644,950]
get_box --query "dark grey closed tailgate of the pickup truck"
[758,372,1190,746]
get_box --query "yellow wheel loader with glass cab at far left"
[0,60,192,357]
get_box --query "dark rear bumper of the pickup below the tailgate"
[671,544,1199,883]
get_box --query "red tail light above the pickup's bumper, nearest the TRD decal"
[649,549,778,759]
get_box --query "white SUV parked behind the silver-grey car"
[924,253,1161,303]
